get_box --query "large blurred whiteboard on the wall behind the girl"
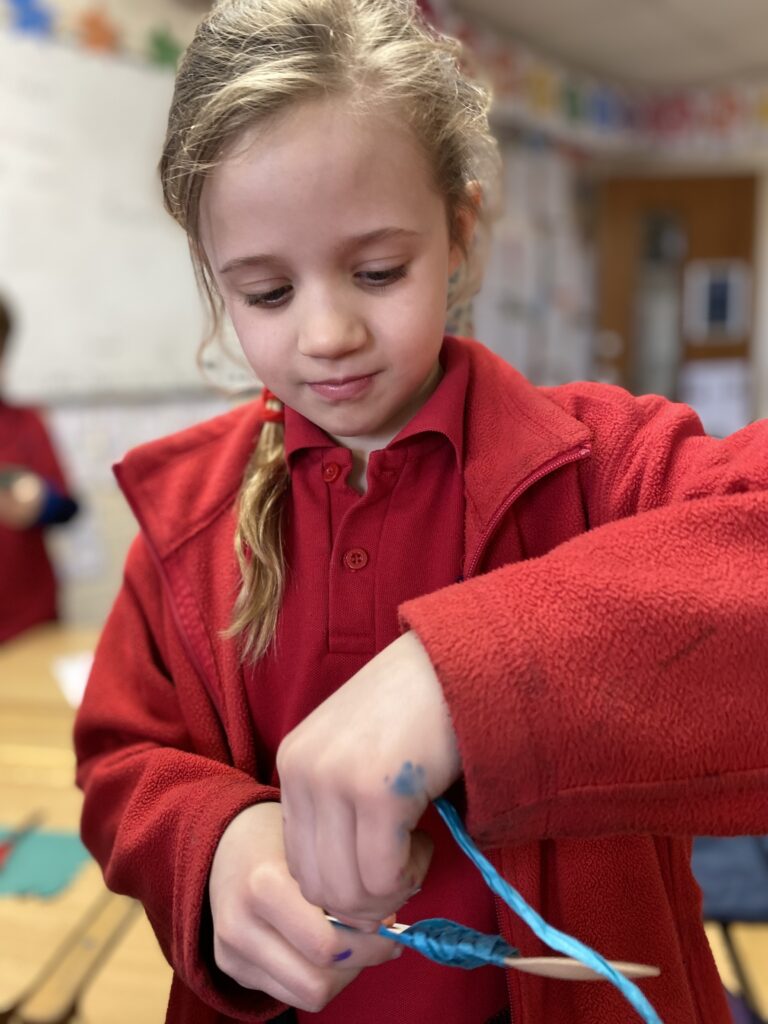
[0,32,252,401]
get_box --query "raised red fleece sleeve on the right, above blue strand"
[400,388,768,846]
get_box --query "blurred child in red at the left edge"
[0,300,77,643]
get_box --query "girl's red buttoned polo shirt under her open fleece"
[247,350,507,1024]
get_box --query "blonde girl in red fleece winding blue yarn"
[76,0,768,1024]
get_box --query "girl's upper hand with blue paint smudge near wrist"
[278,633,461,931]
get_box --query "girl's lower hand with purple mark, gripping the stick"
[208,803,401,1013]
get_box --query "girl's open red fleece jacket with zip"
[76,339,768,1024]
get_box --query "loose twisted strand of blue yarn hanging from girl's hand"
[430,798,662,1024]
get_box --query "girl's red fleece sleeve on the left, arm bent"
[75,539,286,1021]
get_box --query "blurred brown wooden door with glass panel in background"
[595,175,756,398]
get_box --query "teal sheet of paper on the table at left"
[0,827,90,897]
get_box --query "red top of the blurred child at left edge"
[0,400,68,643]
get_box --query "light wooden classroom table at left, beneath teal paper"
[0,626,170,1024]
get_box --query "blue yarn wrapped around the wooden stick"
[379,918,520,971]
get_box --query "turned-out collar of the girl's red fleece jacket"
[115,337,589,558]
